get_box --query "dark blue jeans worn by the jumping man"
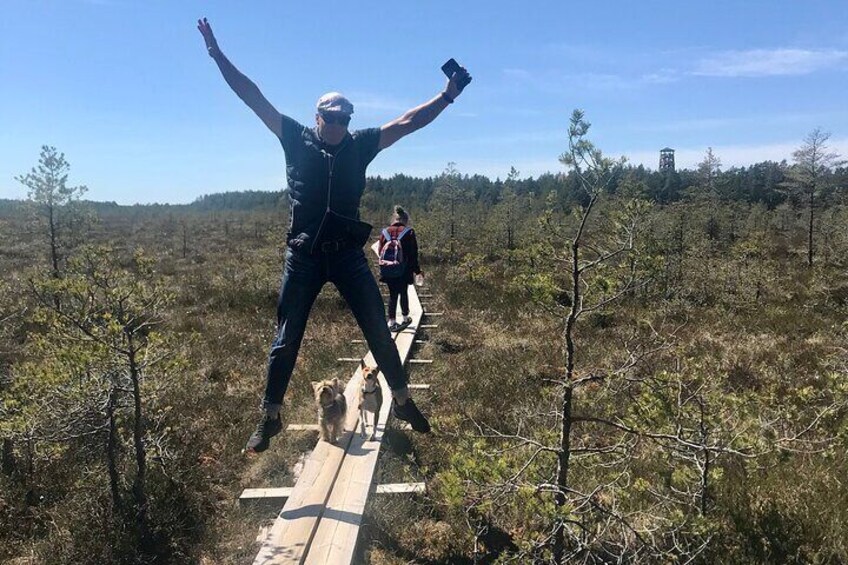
[263,248,407,406]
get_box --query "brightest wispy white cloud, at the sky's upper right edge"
[691,49,848,77]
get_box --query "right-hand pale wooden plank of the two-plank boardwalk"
[304,287,423,565]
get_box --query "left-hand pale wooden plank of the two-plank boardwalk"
[253,353,372,565]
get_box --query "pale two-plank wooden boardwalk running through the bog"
[254,285,424,565]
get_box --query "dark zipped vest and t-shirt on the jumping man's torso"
[280,116,380,243]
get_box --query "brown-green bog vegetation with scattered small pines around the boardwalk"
[0,118,848,564]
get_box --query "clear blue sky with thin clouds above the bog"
[0,0,848,204]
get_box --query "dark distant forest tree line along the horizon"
[0,141,848,214]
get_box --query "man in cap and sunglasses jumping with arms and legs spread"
[197,18,470,453]
